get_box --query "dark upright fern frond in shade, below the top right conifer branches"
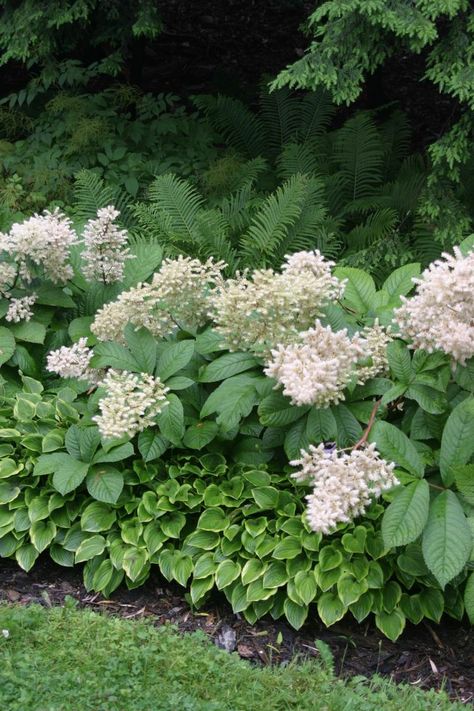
[334,113,383,204]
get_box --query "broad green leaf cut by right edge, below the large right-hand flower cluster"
[439,398,474,486]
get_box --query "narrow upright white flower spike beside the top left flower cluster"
[81,205,133,284]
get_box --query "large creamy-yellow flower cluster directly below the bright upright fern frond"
[210,250,345,356]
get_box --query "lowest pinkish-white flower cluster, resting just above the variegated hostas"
[290,444,399,534]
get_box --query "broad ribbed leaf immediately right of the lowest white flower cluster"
[382,479,430,548]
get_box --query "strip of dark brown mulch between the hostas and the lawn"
[0,559,474,704]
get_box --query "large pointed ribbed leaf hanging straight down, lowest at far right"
[422,491,472,588]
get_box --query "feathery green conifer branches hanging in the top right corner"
[272,0,474,244]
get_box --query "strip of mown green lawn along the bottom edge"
[0,605,464,711]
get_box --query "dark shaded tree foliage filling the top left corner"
[0,0,162,105]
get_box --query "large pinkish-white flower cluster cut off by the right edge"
[395,247,474,364]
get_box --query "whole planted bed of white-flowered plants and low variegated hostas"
[0,207,474,639]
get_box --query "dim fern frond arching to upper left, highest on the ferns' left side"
[194,96,266,158]
